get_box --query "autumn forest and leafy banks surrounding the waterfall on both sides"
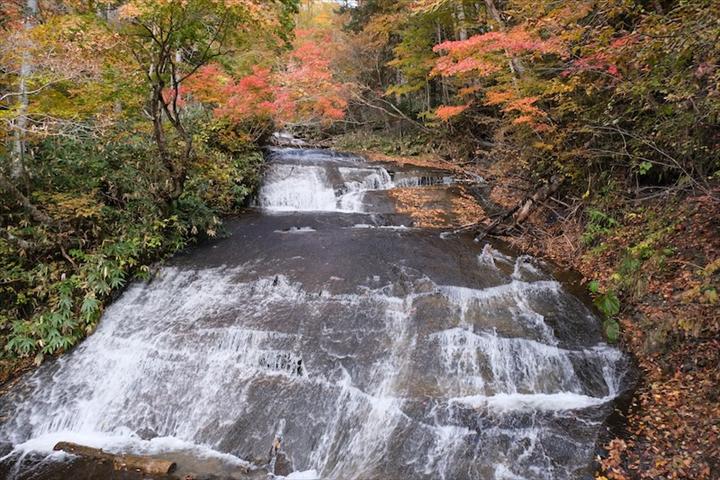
[0,0,720,479]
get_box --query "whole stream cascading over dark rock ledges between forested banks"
[0,149,628,480]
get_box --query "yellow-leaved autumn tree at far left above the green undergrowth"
[0,1,132,234]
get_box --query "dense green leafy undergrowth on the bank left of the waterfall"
[0,112,262,372]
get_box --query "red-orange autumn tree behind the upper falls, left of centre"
[178,1,348,133]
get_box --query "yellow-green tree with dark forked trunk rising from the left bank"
[120,0,297,202]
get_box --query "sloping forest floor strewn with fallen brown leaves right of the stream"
[344,138,720,480]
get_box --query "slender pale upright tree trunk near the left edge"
[10,0,38,181]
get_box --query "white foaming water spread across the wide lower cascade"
[0,244,622,479]
